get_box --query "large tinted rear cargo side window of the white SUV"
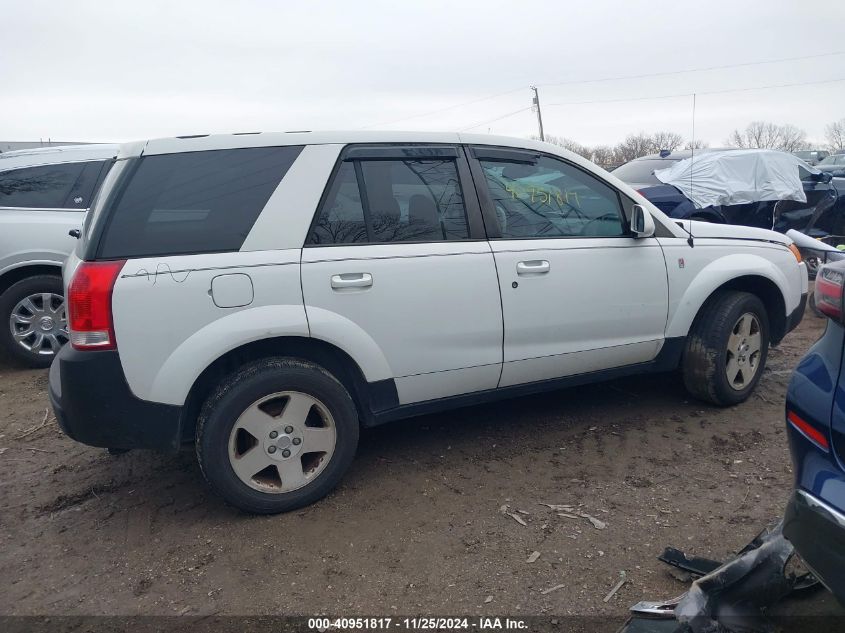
[98,146,302,259]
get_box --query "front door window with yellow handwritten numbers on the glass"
[481,156,625,239]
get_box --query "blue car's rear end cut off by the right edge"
[783,261,845,604]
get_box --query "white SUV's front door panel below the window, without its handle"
[491,238,668,386]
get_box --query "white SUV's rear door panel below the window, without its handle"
[302,242,502,404]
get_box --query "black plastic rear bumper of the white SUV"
[49,345,182,451]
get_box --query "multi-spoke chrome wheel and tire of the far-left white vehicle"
[0,275,68,368]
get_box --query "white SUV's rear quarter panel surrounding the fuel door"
[112,249,308,404]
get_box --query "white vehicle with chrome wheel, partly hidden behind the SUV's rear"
[0,144,118,367]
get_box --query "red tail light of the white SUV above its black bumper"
[67,261,126,350]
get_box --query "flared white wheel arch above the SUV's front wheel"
[666,253,800,338]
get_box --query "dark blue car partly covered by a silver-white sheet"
[612,149,845,237]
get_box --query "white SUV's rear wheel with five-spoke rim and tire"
[196,358,359,514]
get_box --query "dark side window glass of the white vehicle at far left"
[0,161,104,209]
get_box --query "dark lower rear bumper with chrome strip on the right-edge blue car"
[783,489,845,604]
